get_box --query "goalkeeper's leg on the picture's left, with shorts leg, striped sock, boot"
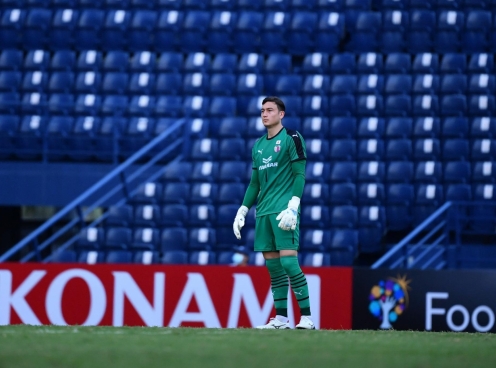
[254,216,289,329]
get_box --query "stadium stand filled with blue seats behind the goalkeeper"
[0,0,496,266]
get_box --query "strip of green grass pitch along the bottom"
[0,326,496,368]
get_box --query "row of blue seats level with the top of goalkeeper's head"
[0,92,496,118]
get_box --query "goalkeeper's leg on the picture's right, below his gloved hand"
[273,217,315,329]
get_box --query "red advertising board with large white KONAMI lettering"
[0,263,352,329]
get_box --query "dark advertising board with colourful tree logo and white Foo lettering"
[353,269,496,332]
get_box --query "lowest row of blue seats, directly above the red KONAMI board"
[51,250,353,267]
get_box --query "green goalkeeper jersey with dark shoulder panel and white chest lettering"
[251,128,307,217]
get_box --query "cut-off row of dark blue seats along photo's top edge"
[5,0,496,10]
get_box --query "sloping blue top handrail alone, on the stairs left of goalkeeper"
[0,119,186,263]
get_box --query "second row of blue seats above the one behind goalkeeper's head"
[0,49,494,78]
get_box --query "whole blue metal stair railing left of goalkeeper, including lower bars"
[0,119,189,262]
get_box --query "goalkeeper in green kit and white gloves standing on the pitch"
[233,97,315,329]
